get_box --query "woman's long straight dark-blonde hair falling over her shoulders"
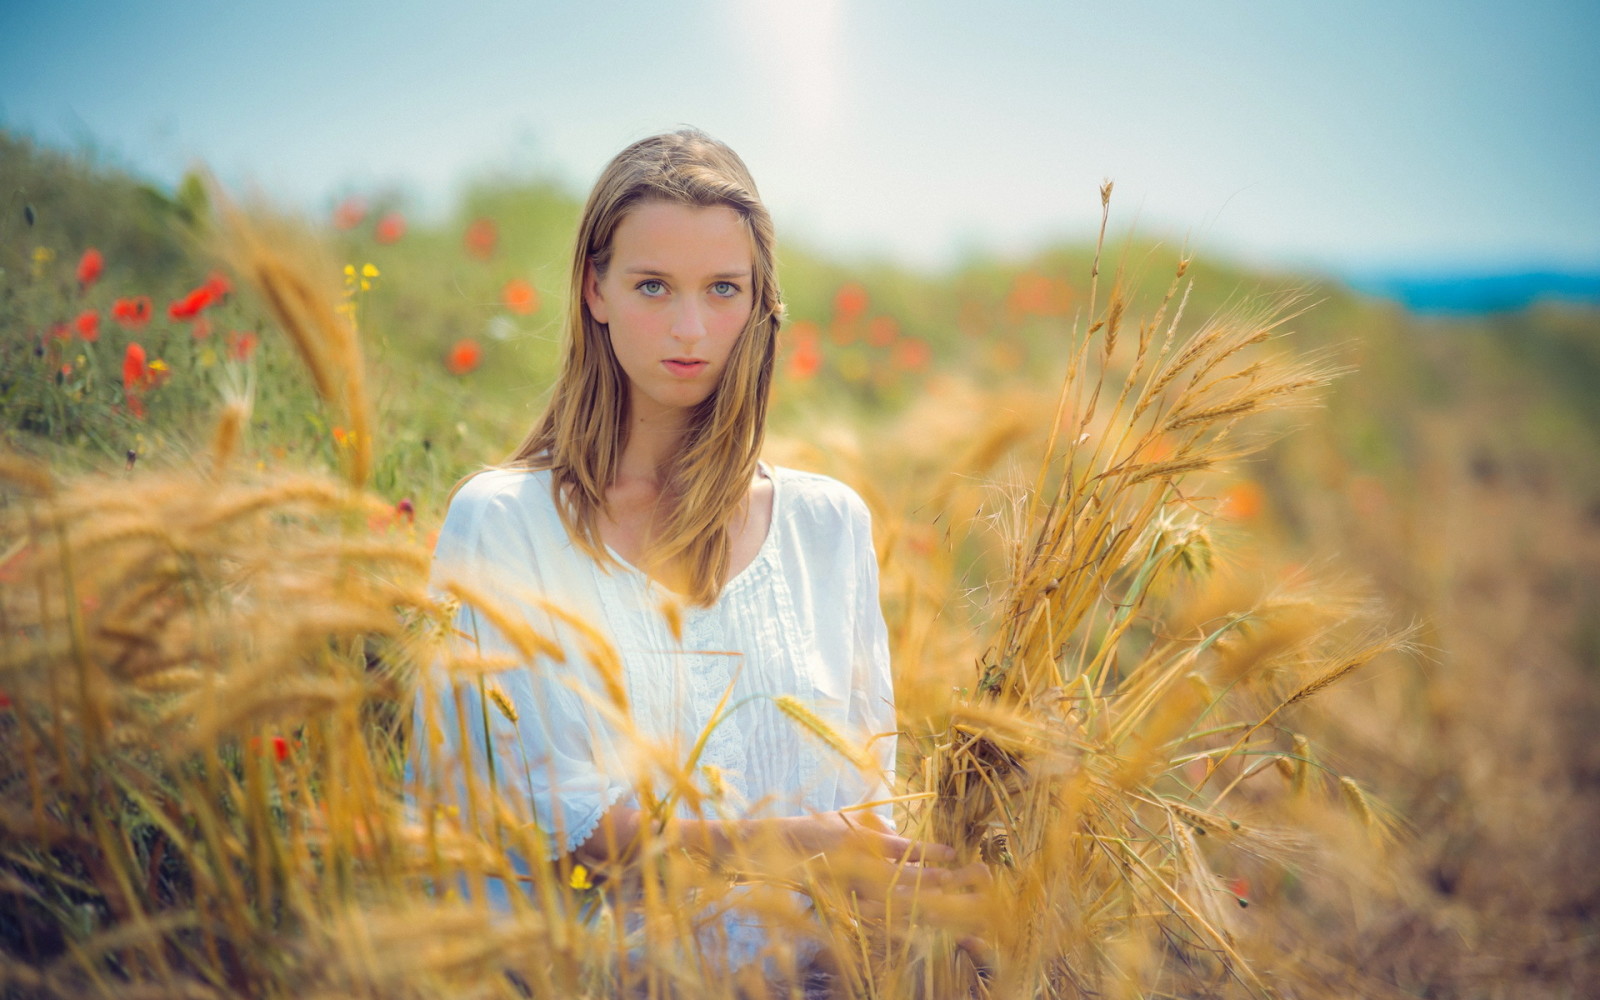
[506,130,782,605]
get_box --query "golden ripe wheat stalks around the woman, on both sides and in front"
[0,190,1402,997]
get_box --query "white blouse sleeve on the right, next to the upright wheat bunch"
[850,498,898,827]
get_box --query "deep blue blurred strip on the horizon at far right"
[1350,270,1600,315]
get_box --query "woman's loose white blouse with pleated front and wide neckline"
[416,469,894,858]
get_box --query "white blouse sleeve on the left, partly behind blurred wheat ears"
[413,483,632,858]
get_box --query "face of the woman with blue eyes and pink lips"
[584,202,755,419]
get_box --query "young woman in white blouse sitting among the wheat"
[418,130,972,963]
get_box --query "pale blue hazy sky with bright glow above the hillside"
[0,0,1600,272]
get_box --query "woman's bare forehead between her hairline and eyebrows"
[611,202,755,274]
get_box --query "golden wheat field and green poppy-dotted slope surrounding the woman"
[0,134,1600,998]
